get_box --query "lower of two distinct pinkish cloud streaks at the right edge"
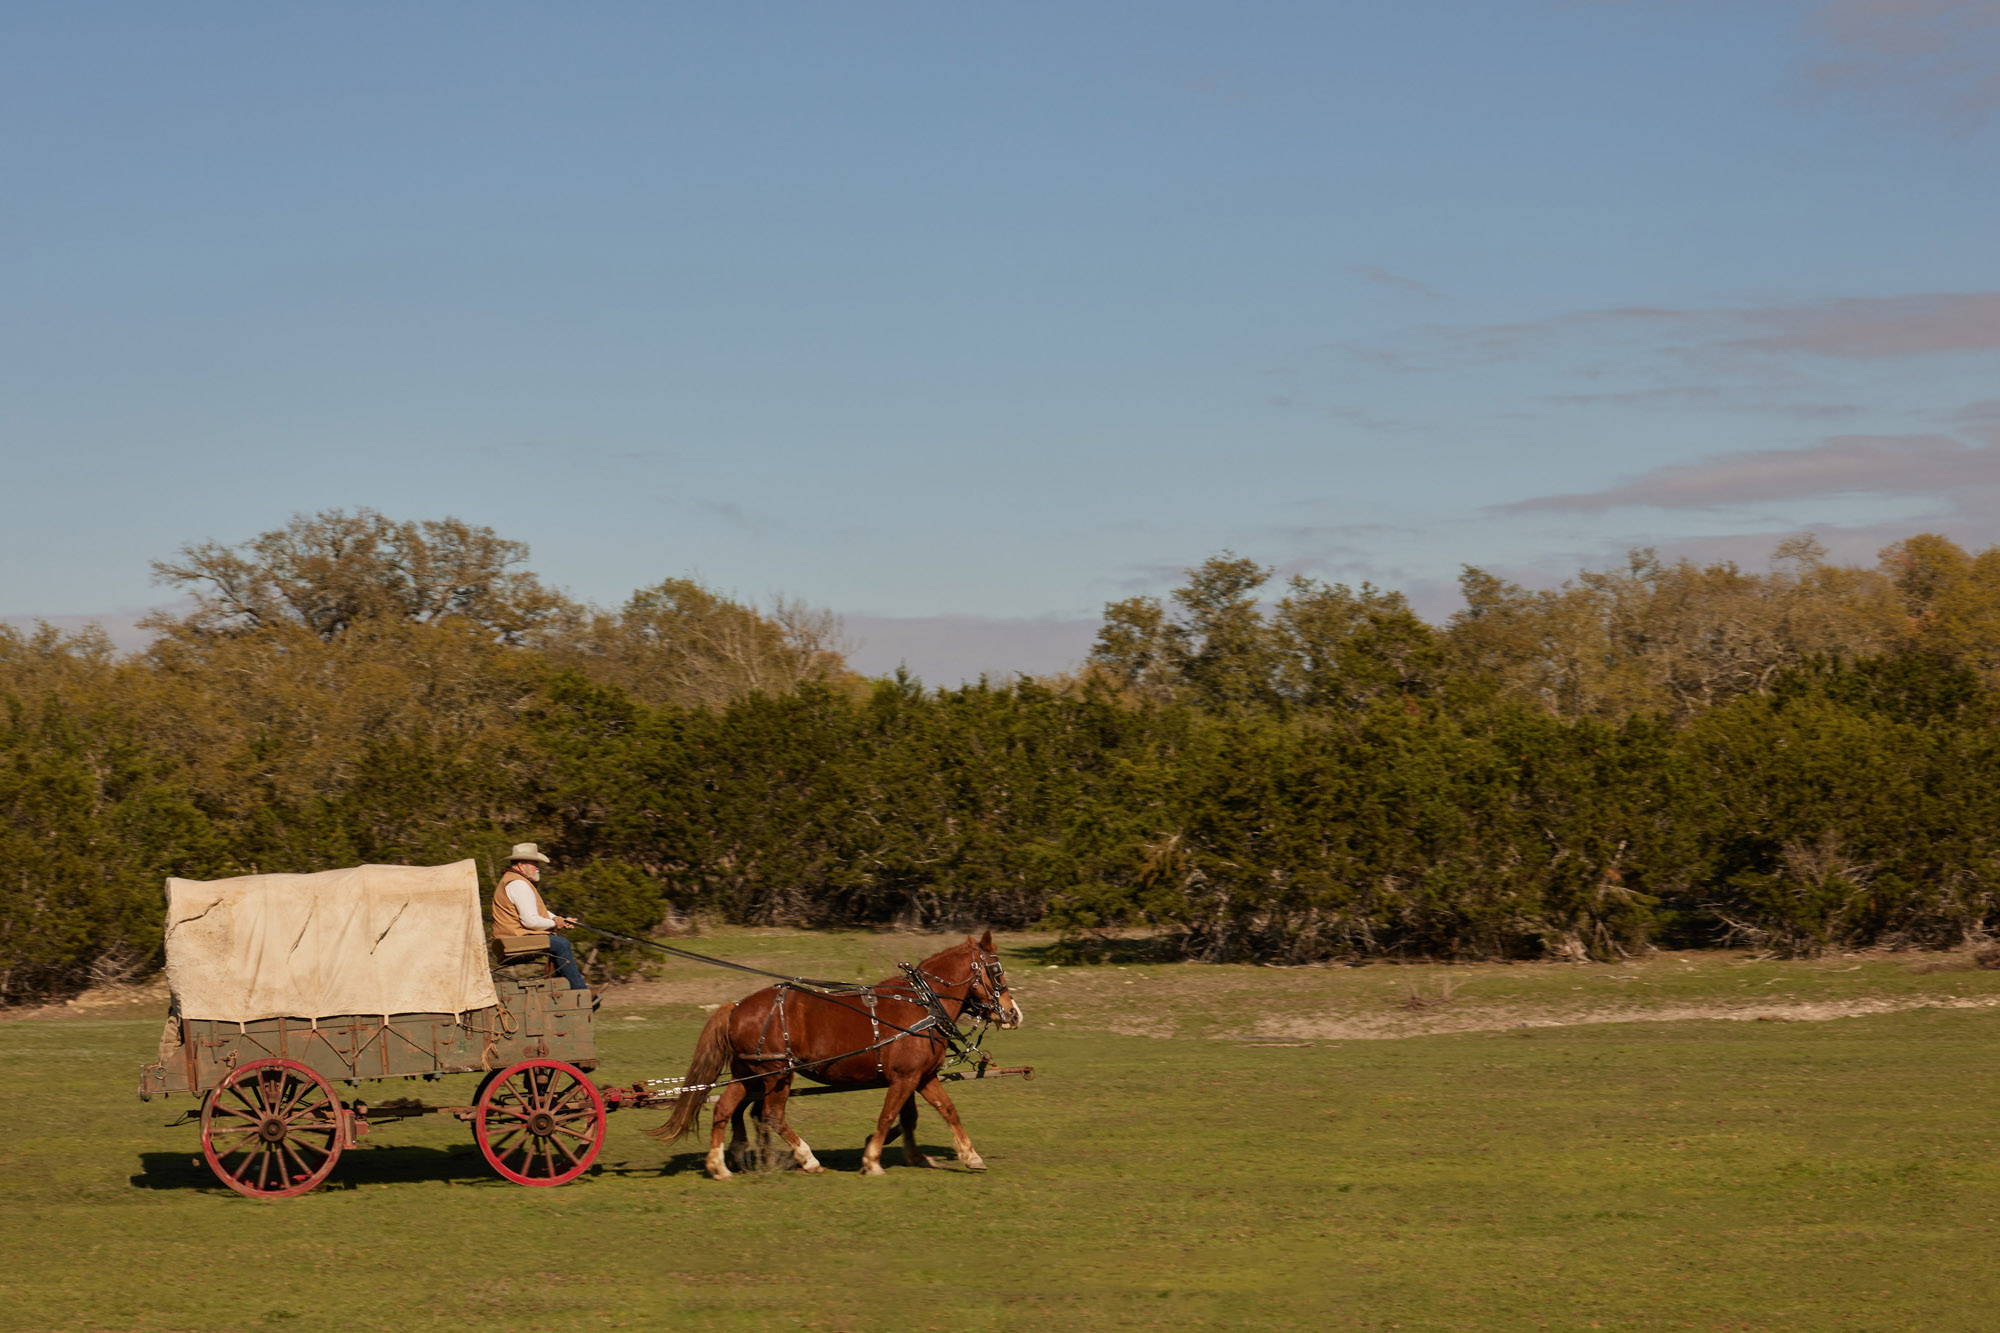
[1494,434,2000,514]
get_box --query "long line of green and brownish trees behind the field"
[0,510,2000,1003]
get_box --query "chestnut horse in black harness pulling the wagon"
[646,931,1020,1181]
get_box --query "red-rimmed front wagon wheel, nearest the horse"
[472,1061,604,1185]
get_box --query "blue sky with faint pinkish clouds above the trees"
[0,0,2000,681]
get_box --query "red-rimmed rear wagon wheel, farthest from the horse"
[202,1059,340,1199]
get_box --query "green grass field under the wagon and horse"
[0,933,2000,1331]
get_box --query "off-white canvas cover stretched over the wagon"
[166,861,498,1023]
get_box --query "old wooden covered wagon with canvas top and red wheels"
[138,861,606,1199]
